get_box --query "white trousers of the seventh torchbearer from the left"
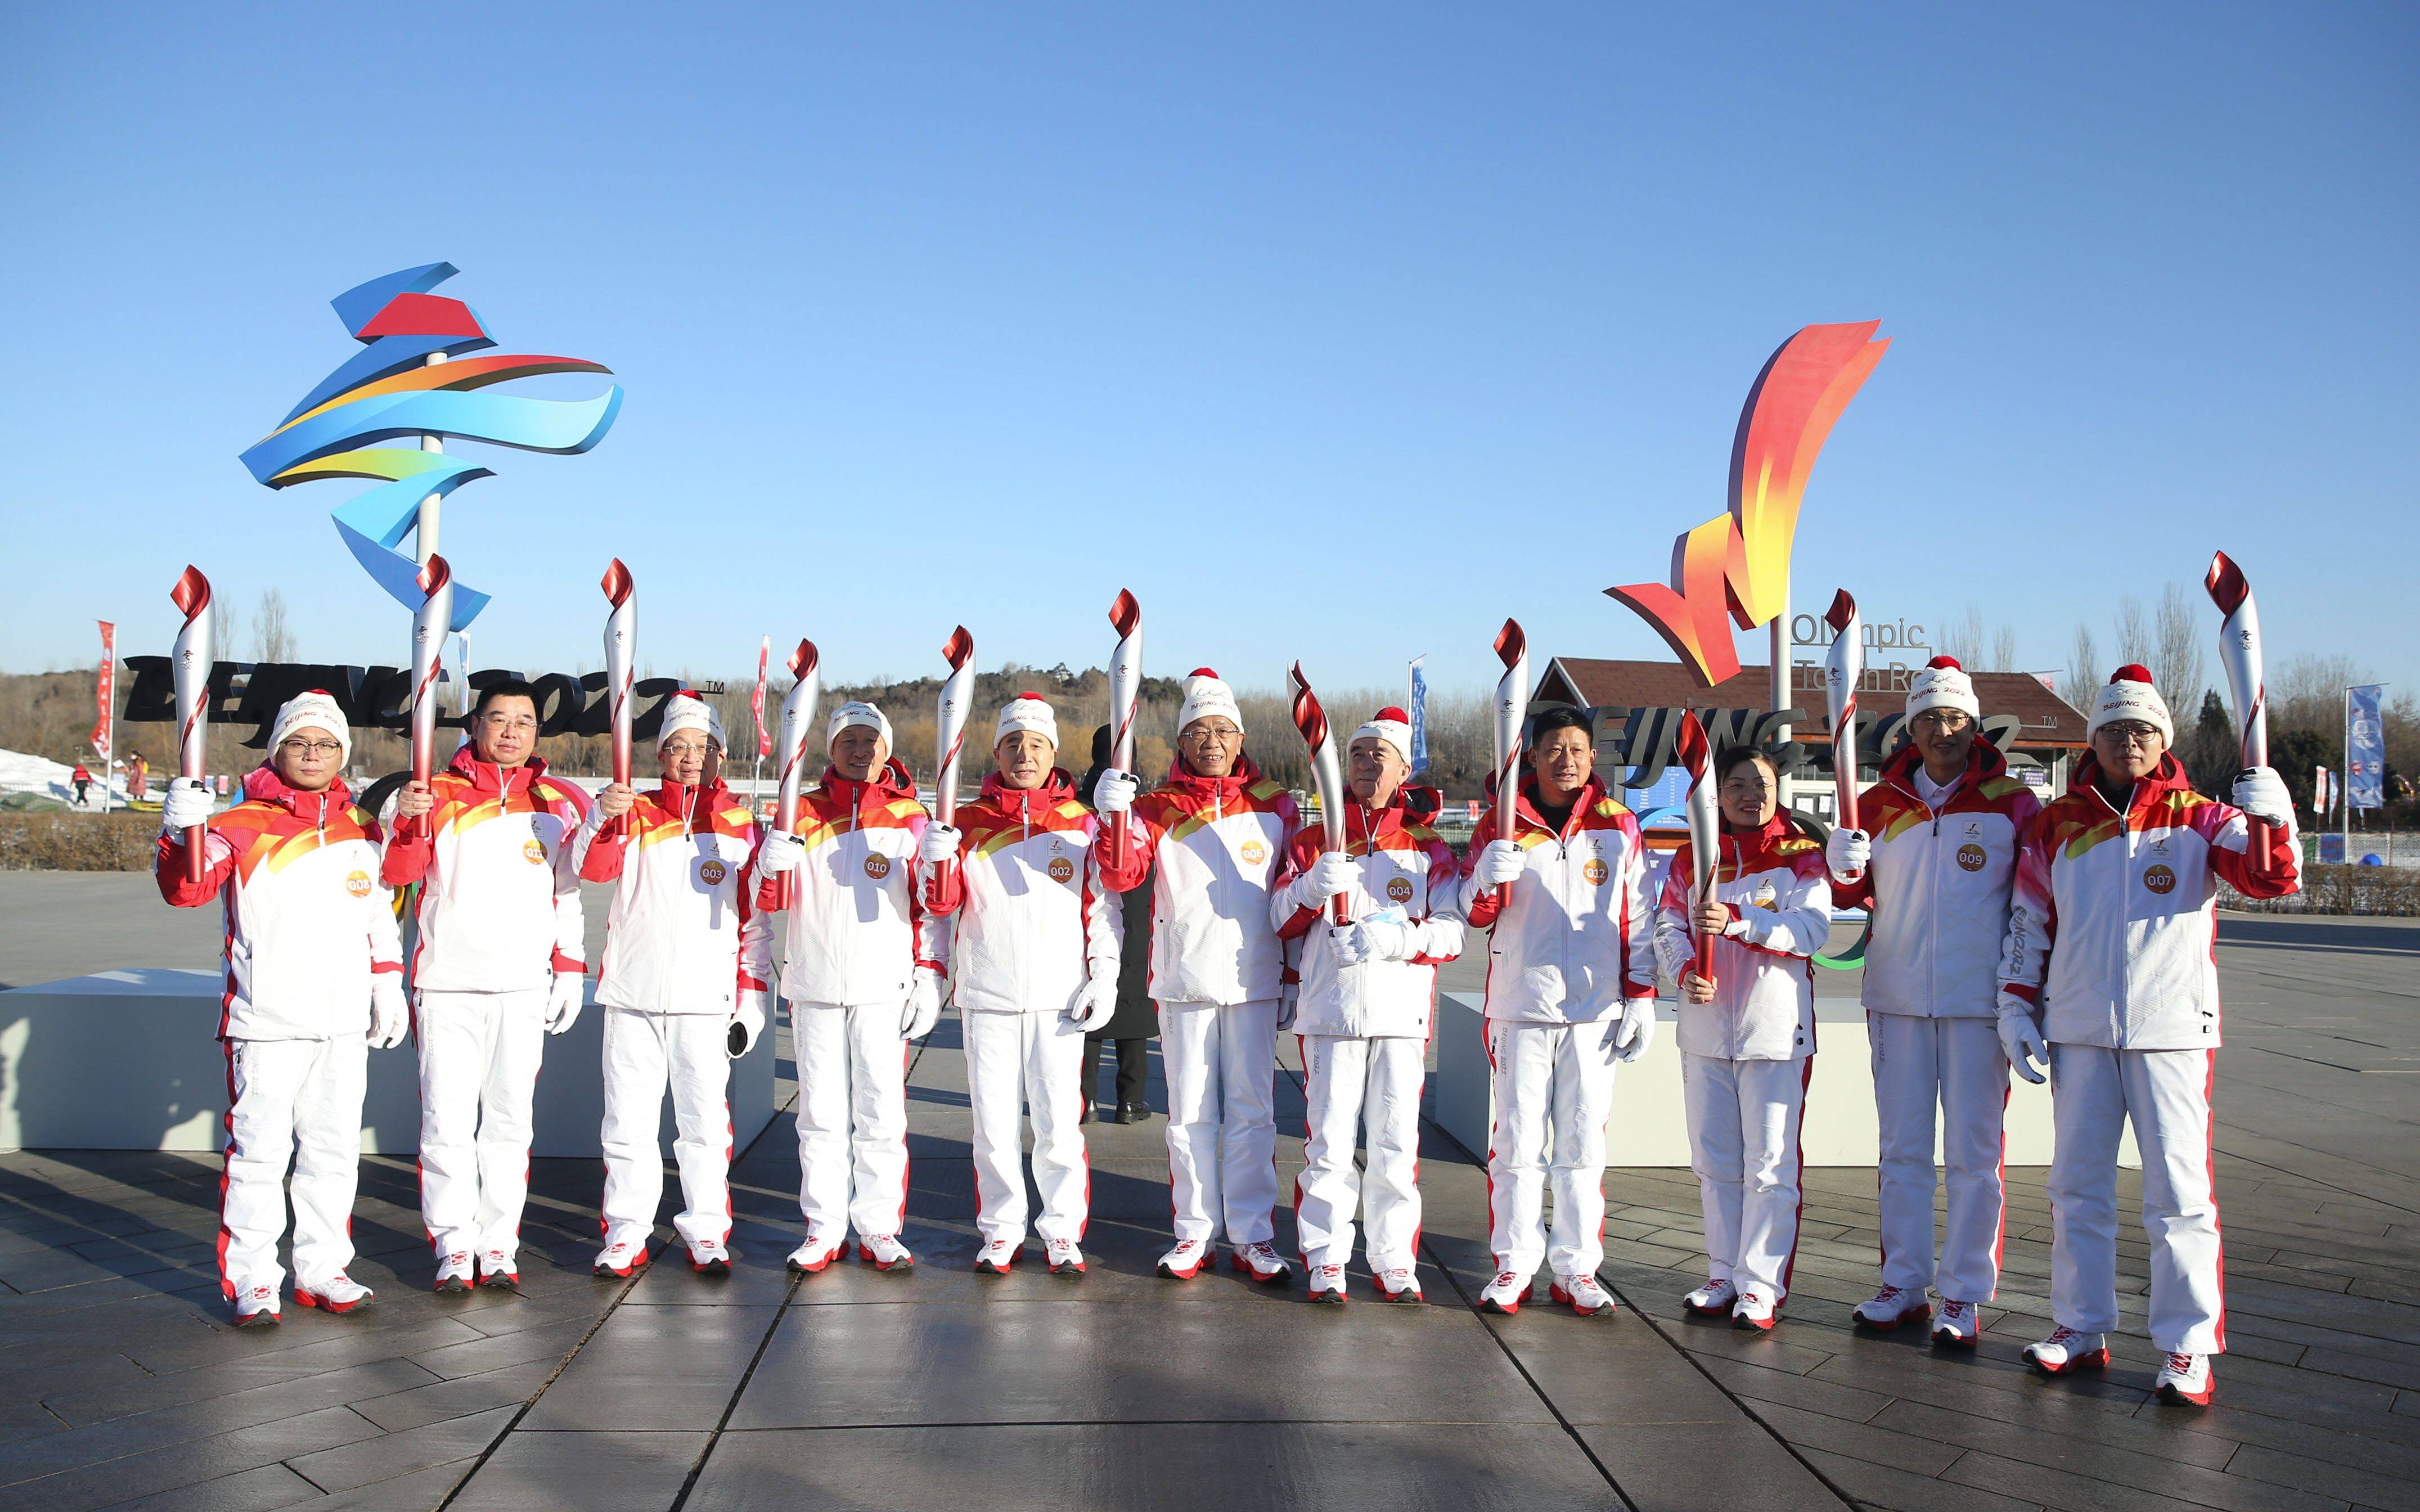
[1295,1036,1428,1270]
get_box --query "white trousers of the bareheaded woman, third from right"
[1680,1055,1815,1302]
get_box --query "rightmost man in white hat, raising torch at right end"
[1999,665,2301,1406]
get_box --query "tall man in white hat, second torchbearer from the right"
[1825,656,2043,1350]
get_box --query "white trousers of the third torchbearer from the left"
[598,1009,731,1248]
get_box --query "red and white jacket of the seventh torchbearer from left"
[1268,789,1461,1040]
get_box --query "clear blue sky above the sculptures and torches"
[0,5,2420,687]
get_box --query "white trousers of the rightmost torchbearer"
[2050,1045,2226,1354]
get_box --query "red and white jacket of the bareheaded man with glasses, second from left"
[383,745,588,992]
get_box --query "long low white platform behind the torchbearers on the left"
[0,968,775,1156]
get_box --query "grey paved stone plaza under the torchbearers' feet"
[0,874,2420,1512]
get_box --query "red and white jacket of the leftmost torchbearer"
[152,767,404,1040]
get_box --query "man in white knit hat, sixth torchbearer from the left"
[1094,668,1299,1285]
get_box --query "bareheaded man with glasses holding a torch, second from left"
[383,677,588,1292]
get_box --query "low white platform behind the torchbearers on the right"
[1435,992,2142,1168]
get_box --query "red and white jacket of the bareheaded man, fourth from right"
[1461,777,1656,1023]
